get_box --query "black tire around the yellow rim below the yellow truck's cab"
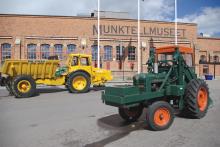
[67,72,91,93]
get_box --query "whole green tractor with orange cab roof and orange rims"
[102,46,212,131]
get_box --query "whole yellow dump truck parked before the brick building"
[0,54,112,98]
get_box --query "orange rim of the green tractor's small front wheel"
[154,108,170,126]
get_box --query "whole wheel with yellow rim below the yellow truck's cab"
[67,72,90,93]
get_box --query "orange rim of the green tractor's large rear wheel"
[197,87,208,111]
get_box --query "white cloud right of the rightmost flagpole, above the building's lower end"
[178,7,220,36]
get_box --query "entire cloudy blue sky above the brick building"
[0,0,220,37]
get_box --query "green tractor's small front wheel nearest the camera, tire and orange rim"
[146,101,174,131]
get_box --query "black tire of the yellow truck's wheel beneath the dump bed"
[11,75,36,98]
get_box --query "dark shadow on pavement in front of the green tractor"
[85,114,146,147]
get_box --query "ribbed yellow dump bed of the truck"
[1,60,59,79]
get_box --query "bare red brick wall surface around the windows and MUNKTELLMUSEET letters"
[0,15,218,77]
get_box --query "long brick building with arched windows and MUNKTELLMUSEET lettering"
[0,14,220,77]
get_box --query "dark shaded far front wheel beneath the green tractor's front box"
[118,105,143,122]
